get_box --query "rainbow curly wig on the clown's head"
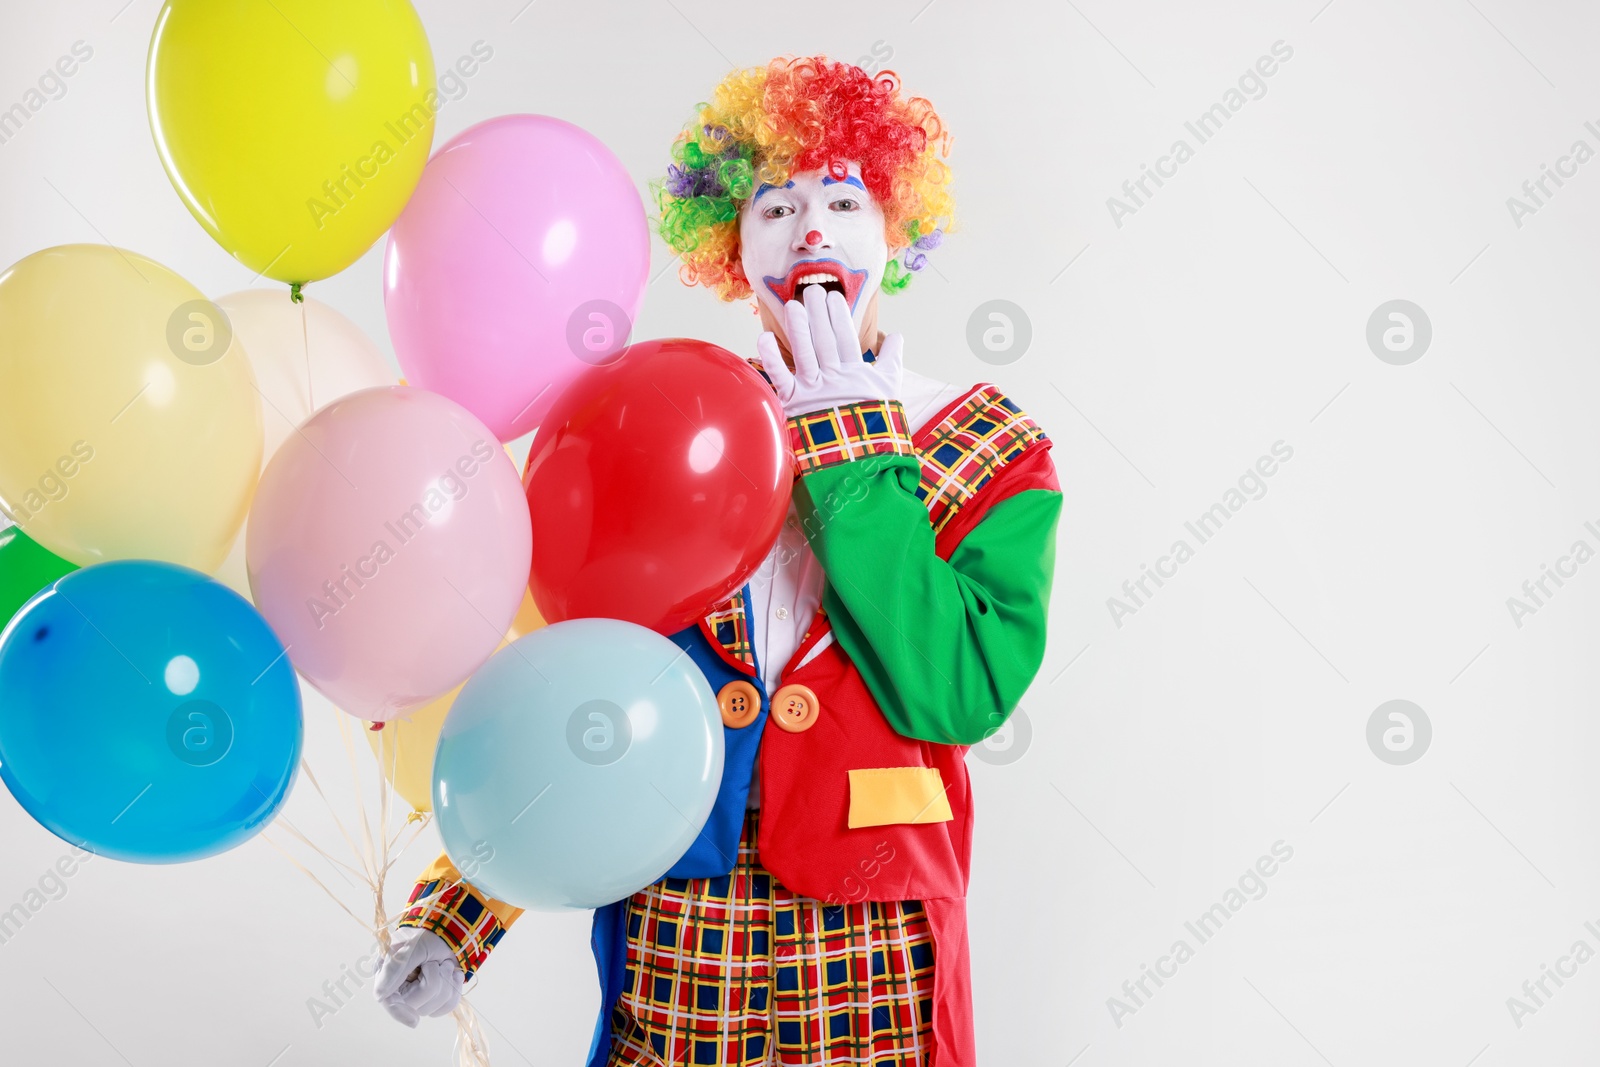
[651,56,954,301]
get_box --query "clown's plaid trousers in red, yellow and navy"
[608,811,934,1067]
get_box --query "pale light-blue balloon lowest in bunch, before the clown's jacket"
[434,619,723,910]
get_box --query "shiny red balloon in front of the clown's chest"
[523,338,794,633]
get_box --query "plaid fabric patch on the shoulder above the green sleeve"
[917,384,1046,533]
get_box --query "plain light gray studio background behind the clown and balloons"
[0,0,1600,1067]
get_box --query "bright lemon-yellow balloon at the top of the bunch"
[146,0,438,283]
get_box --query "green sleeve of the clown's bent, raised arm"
[795,454,1061,745]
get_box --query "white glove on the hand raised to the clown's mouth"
[755,285,906,416]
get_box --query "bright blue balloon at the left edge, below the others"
[0,560,302,864]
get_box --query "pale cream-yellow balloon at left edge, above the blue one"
[0,245,262,574]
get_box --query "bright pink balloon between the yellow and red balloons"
[384,115,650,442]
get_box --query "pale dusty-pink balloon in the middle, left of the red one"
[245,386,533,721]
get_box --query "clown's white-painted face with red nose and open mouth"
[739,163,890,328]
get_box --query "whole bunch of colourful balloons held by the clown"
[0,0,792,907]
